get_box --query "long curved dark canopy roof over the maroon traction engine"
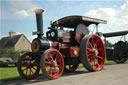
[52,16,107,28]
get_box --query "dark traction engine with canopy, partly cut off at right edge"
[103,30,128,64]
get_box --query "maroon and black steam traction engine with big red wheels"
[18,9,107,79]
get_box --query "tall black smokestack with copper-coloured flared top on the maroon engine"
[33,9,44,38]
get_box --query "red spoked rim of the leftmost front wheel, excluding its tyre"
[20,53,40,79]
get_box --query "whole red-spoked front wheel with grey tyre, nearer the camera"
[40,49,64,79]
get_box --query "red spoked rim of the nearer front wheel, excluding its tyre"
[44,51,64,78]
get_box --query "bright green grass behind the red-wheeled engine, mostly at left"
[0,61,113,82]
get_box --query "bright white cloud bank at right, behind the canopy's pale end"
[85,1,128,43]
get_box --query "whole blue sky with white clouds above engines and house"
[0,0,128,42]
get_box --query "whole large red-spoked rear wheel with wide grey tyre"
[80,35,106,71]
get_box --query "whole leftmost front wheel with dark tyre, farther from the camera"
[17,52,40,79]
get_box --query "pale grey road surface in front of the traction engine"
[2,62,128,85]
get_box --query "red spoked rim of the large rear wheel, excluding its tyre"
[86,35,106,70]
